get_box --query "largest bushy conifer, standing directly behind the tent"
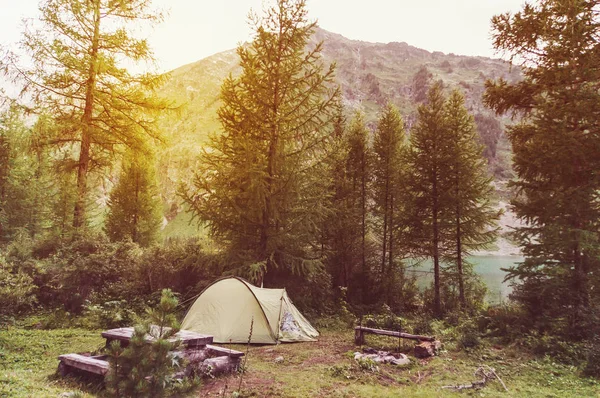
[183,0,339,283]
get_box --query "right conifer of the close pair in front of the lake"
[445,90,499,309]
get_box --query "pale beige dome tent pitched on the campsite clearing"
[181,277,319,344]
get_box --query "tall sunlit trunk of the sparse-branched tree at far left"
[73,0,100,228]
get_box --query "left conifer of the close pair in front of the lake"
[406,82,454,316]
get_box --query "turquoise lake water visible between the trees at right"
[408,256,523,304]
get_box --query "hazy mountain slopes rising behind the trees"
[155,29,521,243]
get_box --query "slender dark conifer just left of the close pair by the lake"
[373,104,407,297]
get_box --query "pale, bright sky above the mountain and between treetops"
[0,0,524,71]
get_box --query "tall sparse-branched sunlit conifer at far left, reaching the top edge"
[0,0,167,228]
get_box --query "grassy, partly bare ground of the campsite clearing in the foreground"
[0,328,600,398]
